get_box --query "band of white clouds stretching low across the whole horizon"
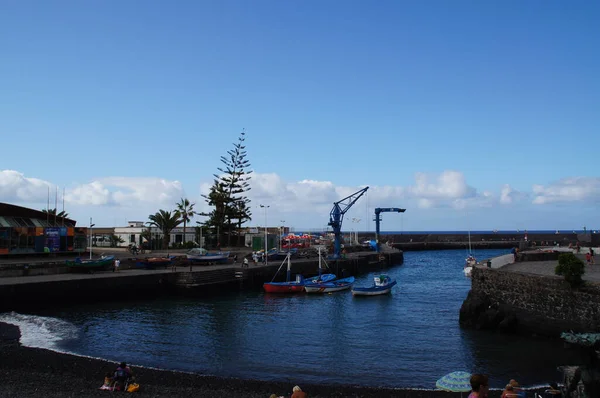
[5,170,600,226]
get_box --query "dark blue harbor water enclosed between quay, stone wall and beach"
[0,250,575,389]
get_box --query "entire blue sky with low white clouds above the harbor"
[0,0,600,230]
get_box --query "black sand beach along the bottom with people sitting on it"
[0,322,544,398]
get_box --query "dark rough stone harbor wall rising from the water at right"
[459,267,600,337]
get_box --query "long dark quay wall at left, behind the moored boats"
[0,251,403,312]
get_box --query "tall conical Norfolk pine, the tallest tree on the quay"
[200,131,252,246]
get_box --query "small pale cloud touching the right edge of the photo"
[532,177,600,204]
